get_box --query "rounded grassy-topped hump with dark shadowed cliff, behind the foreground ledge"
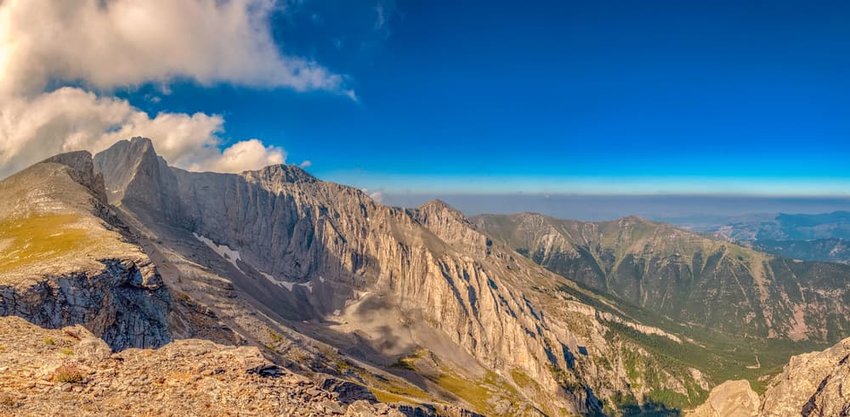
[0,152,172,350]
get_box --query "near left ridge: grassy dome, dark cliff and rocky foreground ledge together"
[0,147,464,416]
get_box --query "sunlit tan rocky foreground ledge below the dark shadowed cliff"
[0,317,438,417]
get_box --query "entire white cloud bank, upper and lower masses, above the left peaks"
[0,0,338,178]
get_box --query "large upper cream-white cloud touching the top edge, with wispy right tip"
[0,0,350,95]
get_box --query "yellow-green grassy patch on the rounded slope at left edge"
[0,214,92,273]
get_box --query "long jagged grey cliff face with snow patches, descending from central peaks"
[95,139,704,414]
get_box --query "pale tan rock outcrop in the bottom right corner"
[688,339,850,417]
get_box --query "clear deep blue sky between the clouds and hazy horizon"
[125,0,850,195]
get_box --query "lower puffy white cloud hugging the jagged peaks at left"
[0,87,286,178]
